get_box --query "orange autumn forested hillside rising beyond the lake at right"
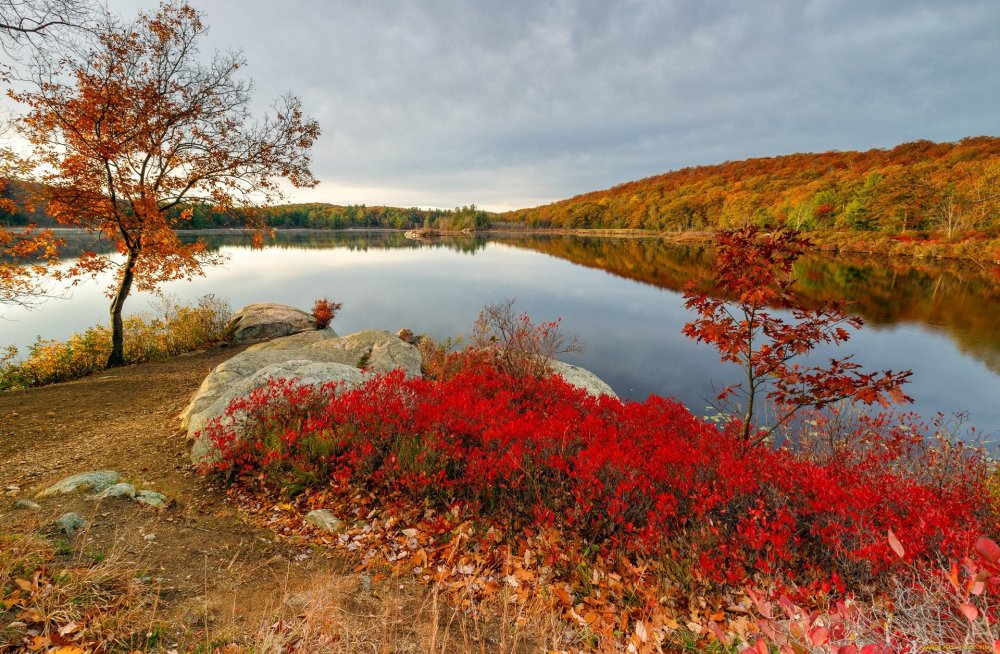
[499,137,1000,238]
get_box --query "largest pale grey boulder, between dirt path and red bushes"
[181,330,421,464]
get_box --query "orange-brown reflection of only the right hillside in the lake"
[505,237,1000,373]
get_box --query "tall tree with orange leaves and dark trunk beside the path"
[14,3,319,367]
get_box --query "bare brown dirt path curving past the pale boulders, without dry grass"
[0,348,368,649]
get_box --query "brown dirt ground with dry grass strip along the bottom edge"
[0,348,556,654]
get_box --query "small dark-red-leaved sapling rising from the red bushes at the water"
[683,225,911,444]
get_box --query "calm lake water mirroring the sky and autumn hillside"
[0,233,1000,434]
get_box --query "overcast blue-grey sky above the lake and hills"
[21,0,1000,210]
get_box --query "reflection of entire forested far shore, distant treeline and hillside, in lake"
[50,230,1000,373]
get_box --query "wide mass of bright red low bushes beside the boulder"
[201,359,986,596]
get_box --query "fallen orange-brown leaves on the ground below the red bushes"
[229,486,757,652]
